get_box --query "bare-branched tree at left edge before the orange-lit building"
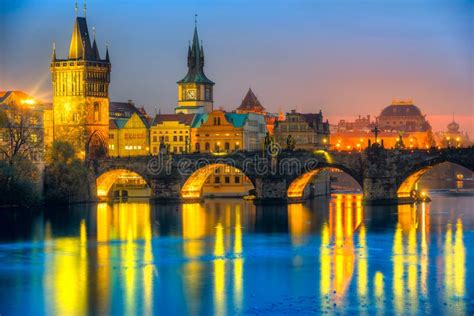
[0,104,43,165]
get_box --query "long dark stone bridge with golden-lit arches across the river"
[88,147,474,204]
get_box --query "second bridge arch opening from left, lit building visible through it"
[181,163,254,199]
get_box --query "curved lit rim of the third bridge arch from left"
[287,164,363,199]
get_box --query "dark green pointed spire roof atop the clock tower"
[178,25,214,85]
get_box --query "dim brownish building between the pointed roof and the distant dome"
[274,110,330,150]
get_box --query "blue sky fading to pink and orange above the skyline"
[0,0,474,136]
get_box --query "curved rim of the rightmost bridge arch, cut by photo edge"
[397,156,474,198]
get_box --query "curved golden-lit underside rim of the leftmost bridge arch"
[95,168,151,200]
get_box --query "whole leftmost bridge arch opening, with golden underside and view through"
[96,169,151,201]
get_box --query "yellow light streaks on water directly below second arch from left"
[182,201,244,315]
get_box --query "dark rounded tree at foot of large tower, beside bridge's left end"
[44,141,89,205]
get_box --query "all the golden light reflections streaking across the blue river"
[36,195,467,315]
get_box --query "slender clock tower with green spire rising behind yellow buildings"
[175,20,214,114]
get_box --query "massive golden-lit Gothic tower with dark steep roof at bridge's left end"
[51,9,111,158]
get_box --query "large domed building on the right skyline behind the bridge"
[377,100,431,132]
